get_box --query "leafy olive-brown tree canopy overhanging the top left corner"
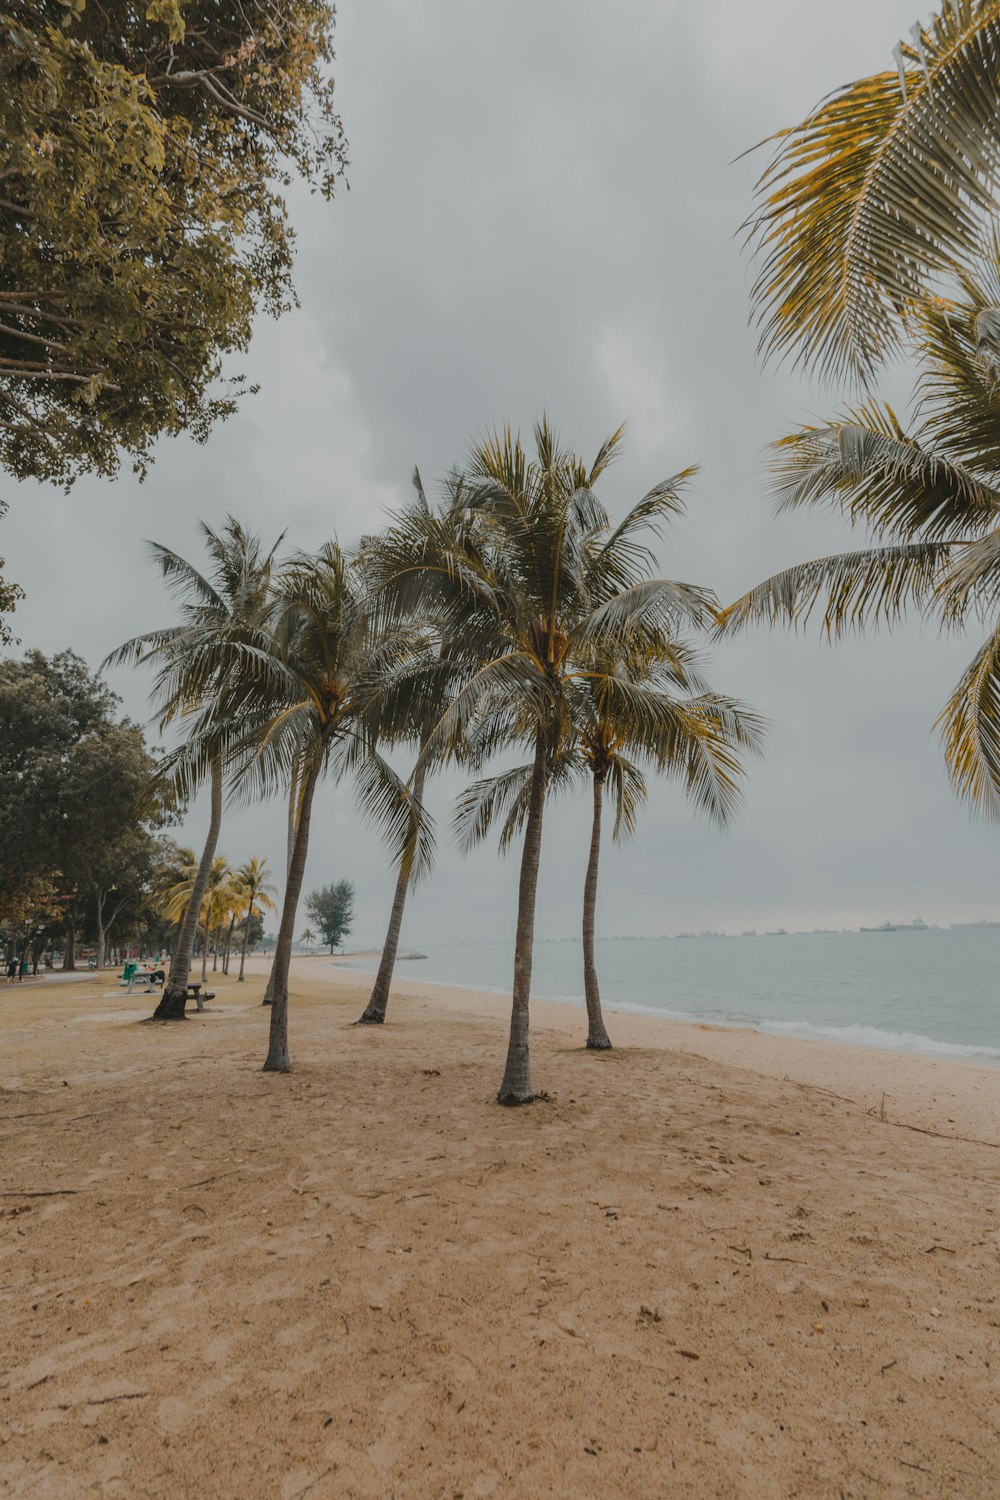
[0,0,345,483]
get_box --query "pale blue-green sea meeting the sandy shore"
[340,927,1000,1064]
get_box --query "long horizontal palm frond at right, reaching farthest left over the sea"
[717,542,954,638]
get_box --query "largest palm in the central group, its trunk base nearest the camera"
[367,420,715,1104]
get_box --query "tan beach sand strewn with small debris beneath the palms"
[0,959,1000,1500]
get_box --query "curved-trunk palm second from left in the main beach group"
[160,543,432,1073]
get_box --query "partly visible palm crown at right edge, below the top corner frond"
[720,273,1000,818]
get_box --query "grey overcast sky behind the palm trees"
[0,0,1000,945]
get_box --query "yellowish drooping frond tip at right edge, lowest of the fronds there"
[937,630,1000,822]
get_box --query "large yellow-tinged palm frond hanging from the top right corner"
[747,0,1000,381]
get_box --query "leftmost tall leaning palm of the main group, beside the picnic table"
[105,516,283,1020]
